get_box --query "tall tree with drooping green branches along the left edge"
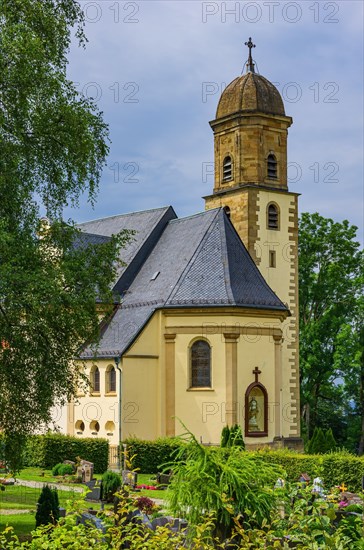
[0,0,128,471]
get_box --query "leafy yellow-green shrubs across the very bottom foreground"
[0,488,364,550]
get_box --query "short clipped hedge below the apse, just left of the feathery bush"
[123,437,183,474]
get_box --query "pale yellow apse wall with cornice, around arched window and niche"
[165,309,282,444]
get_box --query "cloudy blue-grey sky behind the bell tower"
[64,0,364,240]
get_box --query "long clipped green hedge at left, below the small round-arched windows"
[24,434,109,474]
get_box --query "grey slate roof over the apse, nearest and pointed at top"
[82,208,287,358]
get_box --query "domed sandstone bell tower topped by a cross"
[204,38,300,438]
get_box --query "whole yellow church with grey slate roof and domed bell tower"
[66,39,301,448]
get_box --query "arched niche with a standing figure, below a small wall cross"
[245,382,268,437]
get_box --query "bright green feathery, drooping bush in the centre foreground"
[167,433,284,540]
